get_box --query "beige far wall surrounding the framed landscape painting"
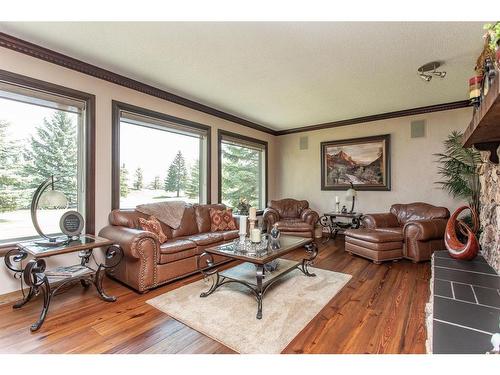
[276,108,471,214]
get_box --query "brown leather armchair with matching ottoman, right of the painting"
[345,202,450,263]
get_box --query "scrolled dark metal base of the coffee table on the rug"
[197,242,318,319]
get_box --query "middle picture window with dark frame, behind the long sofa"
[113,102,210,208]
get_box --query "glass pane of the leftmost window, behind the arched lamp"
[0,95,84,243]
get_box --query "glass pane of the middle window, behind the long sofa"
[120,121,206,208]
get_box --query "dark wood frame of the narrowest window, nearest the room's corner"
[217,129,269,215]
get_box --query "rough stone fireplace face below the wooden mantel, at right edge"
[479,162,500,272]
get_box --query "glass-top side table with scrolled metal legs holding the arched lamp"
[5,234,123,332]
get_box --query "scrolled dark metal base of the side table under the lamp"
[5,245,123,332]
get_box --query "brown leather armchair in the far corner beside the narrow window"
[263,198,319,238]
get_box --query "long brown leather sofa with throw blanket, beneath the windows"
[99,204,238,292]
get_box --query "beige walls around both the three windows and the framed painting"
[0,48,471,300]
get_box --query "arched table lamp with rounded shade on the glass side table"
[31,176,68,246]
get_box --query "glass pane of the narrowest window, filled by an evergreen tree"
[220,142,265,209]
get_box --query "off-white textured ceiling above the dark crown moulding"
[0,22,483,130]
